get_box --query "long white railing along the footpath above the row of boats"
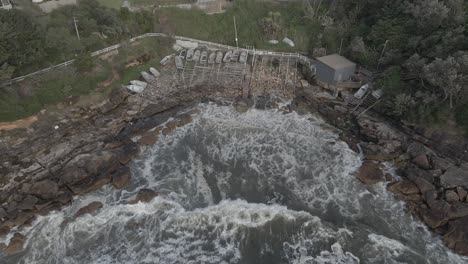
[0,33,313,87]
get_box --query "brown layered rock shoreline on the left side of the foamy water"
[0,83,238,255]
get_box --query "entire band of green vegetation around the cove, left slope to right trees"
[0,0,468,136]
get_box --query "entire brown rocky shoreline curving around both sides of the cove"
[0,83,468,255]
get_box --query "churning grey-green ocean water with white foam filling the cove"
[0,104,468,264]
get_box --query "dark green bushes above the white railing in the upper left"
[0,0,154,78]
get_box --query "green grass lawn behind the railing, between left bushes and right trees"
[157,0,313,51]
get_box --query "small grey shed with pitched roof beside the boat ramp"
[315,54,356,85]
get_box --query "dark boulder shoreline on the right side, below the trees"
[293,87,468,256]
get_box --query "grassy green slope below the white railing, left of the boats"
[0,36,173,121]
